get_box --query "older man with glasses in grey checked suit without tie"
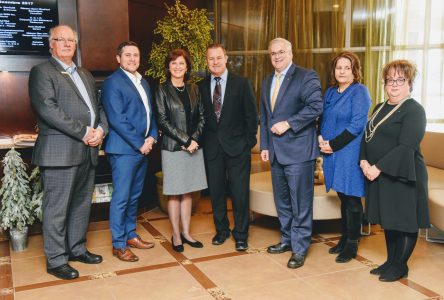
[29,26,108,279]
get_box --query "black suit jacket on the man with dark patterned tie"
[199,72,258,160]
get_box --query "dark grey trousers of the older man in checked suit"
[40,160,95,268]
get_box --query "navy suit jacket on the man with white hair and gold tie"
[260,64,323,165]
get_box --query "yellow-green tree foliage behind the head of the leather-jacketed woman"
[146,0,213,82]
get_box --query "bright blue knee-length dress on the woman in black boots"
[321,83,371,197]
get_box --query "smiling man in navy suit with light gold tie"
[260,38,323,268]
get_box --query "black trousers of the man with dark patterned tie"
[207,150,251,240]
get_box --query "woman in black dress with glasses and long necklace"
[360,60,430,281]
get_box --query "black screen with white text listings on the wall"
[0,0,59,55]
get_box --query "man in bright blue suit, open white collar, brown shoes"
[102,41,157,262]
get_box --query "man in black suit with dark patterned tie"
[200,44,258,251]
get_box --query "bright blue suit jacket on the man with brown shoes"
[102,68,157,155]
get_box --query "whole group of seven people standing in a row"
[29,25,429,281]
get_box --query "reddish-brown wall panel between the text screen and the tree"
[77,0,129,72]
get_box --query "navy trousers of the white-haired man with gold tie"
[271,159,314,255]
